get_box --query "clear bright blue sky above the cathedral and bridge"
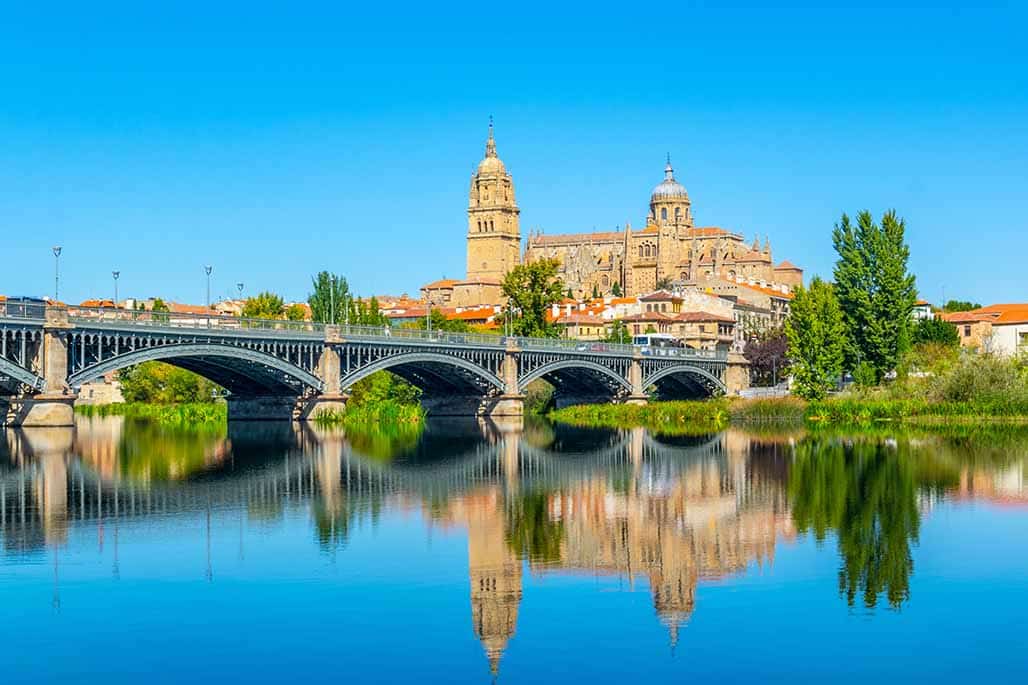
[0,2,1028,302]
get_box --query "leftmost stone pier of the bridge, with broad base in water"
[9,304,75,427]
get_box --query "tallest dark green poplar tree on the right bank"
[832,211,917,382]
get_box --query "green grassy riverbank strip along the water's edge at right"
[548,397,1028,432]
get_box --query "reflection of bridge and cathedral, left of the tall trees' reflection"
[0,417,793,672]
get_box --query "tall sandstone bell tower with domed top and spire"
[468,119,521,282]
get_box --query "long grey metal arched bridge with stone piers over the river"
[0,304,748,426]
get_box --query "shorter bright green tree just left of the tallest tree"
[785,277,846,399]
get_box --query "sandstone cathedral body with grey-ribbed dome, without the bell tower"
[525,158,803,296]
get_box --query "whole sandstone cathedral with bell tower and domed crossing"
[423,121,803,307]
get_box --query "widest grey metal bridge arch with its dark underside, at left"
[68,343,324,396]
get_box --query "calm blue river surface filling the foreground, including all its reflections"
[0,418,1028,683]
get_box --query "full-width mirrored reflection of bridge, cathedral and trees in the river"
[0,417,1028,673]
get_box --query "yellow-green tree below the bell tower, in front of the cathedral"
[503,259,564,337]
